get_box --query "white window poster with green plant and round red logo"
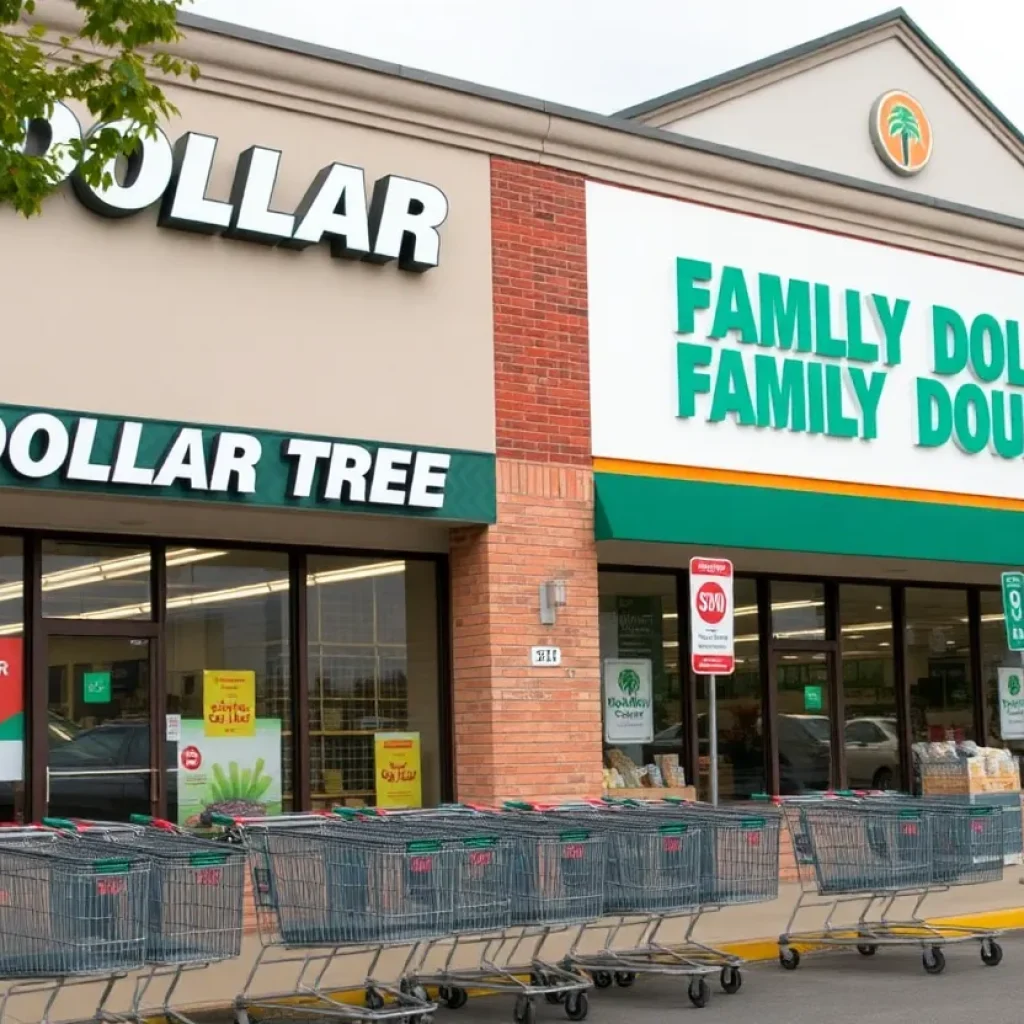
[178,718,282,827]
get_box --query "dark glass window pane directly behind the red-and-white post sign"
[696,580,766,801]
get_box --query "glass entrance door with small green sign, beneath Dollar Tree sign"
[46,635,159,821]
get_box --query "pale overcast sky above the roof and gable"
[186,0,1024,126]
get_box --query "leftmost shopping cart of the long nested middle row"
[213,813,444,1024]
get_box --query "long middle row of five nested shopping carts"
[218,802,781,1024]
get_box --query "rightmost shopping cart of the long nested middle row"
[569,800,781,1007]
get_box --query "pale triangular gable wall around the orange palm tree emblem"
[665,38,1024,217]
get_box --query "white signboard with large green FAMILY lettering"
[587,182,1024,499]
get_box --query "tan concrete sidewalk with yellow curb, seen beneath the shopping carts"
[8,866,1024,1024]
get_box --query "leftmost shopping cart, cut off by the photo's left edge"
[0,828,150,1024]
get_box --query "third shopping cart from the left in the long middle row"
[348,805,605,1024]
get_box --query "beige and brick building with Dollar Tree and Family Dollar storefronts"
[9,4,1024,823]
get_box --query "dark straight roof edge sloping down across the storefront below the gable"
[177,11,1024,230]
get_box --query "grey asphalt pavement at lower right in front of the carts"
[452,936,1024,1024]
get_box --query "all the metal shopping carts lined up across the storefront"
[0,794,1004,1024]
